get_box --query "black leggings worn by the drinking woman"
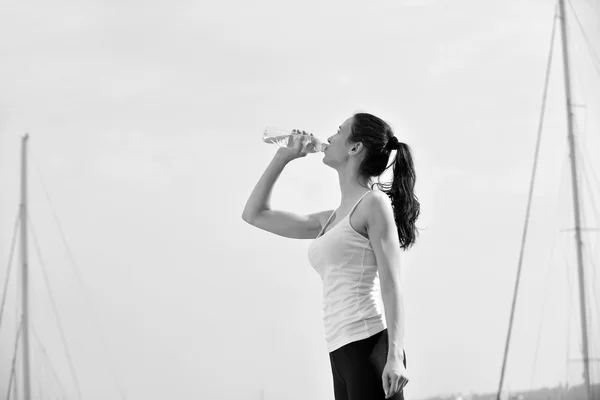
[329,329,406,400]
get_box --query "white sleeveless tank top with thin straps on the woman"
[308,190,387,352]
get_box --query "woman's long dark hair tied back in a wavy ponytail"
[348,113,420,250]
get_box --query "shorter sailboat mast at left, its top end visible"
[20,134,31,400]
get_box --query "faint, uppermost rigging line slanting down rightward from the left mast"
[28,148,126,400]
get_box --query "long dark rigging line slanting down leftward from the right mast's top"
[496,4,558,400]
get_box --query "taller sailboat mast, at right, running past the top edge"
[558,0,592,400]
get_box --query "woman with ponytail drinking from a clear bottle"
[242,113,419,400]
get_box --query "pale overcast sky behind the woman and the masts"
[0,0,600,400]
